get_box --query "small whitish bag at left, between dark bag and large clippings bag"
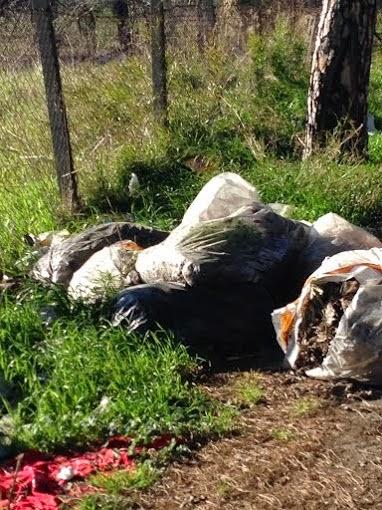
[68,241,141,303]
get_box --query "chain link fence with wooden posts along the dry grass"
[0,0,320,209]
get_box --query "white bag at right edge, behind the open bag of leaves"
[296,213,382,279]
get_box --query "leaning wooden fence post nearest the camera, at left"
[33,0,80,212]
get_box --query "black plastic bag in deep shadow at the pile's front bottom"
[112,282,283,366]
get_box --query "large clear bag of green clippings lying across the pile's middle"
[136,204,310,303]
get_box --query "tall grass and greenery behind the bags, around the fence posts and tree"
[0,18,382,272]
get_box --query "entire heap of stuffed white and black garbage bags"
[31,172,382,382]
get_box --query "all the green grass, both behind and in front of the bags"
[0,7,382,510]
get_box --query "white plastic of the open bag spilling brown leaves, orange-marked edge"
[272,248,382,385]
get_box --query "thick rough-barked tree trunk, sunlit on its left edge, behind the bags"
[304,0,376,157]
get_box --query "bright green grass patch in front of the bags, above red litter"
[0,287,233,450]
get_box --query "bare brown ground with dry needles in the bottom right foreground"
[133,372,382,510]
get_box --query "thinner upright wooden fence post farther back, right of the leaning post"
[151,0,167,126]
